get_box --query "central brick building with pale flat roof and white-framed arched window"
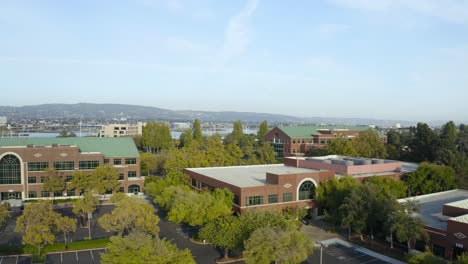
[184,155,418,215]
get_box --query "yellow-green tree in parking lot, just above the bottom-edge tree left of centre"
[98,193,159,235]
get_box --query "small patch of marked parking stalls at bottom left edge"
[46,249,106,264]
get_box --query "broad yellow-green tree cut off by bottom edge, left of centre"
[101,232,195,264]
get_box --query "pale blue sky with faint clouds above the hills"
[0,0,468,121]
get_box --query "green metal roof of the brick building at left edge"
[0,137,140,157]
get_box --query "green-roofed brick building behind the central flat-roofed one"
[265,126,387,159]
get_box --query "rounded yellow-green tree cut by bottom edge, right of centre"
[243,227,314,264]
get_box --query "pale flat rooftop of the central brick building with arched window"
[187,164,319,187]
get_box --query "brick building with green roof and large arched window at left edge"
[0,137,144,200]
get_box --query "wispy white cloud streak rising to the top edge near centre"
[216,0,259,66]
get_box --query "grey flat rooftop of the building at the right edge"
[398,189,468,230]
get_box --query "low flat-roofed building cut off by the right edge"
[398,190,468,260]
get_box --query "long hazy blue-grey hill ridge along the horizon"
[0,103,415,126]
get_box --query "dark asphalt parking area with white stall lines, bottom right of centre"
[307,244,399,264]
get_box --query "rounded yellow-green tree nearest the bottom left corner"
[15,200,61,255]
